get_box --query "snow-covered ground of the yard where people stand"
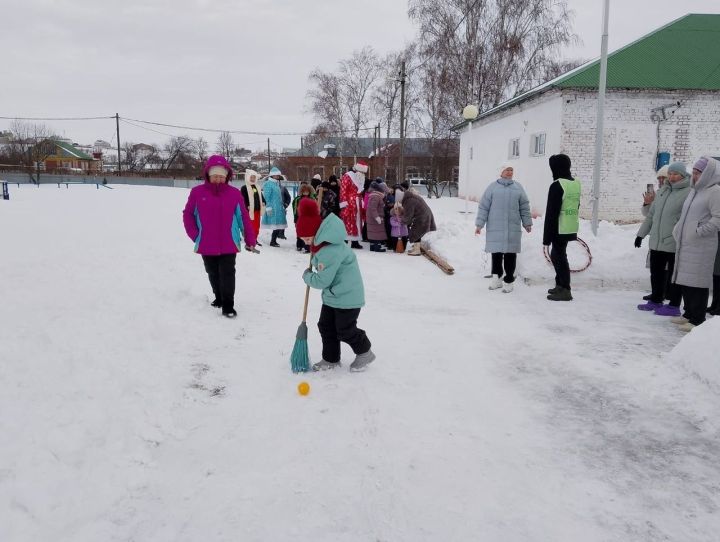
[0,185,720,542]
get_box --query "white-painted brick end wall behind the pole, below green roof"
[560,90,720,222]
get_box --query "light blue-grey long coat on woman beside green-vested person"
[475,179,532,253]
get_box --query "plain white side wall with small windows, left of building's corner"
[459,91,562,214]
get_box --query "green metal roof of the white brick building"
[553,14,720,90]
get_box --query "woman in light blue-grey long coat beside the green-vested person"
[475,165,532,293]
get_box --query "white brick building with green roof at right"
[456,14,720,221]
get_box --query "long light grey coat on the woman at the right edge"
[672,158,720,288]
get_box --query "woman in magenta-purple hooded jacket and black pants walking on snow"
[183,155,257,318]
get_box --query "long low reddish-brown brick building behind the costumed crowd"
[282,137,459,184]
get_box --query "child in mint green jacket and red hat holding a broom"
[295,198,375,371]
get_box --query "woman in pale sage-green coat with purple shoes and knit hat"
[635,162,690,316]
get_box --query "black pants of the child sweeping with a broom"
[318,303,371,363]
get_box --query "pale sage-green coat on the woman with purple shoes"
[637,178,690,252]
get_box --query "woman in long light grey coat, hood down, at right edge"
[673,156,720,331]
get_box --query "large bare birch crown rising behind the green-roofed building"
[409,0,577,115]
